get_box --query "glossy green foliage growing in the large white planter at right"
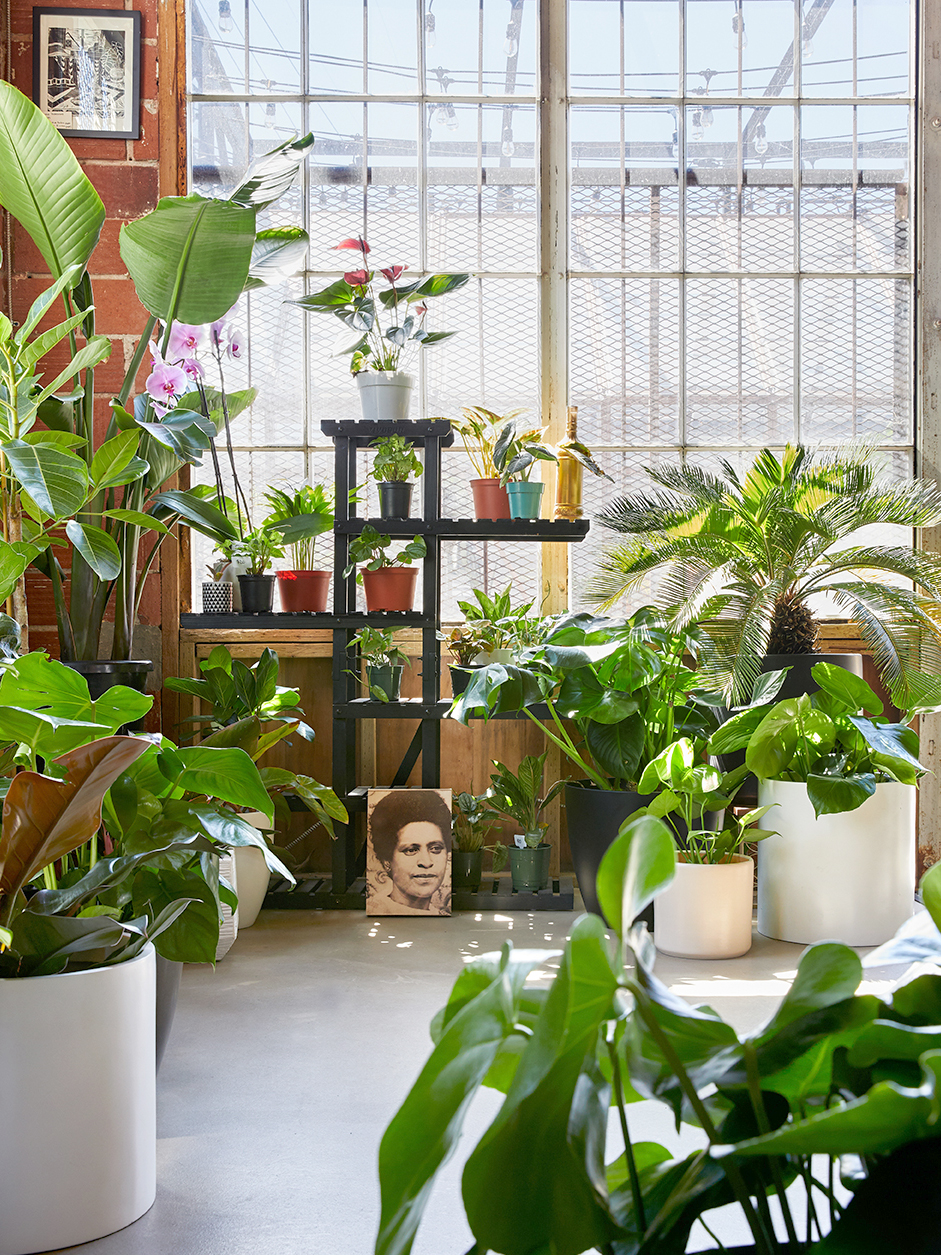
[709,663,941,816]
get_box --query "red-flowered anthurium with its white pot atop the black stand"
[294,238,471,420]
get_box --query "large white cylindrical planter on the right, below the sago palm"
[758,781,915,946]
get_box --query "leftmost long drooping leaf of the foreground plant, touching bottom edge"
[375,944,550,1255]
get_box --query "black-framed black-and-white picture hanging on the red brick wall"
[33,9,141,139]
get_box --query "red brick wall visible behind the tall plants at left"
[0,0,164,655]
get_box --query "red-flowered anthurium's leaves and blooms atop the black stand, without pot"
[294,237,471,375]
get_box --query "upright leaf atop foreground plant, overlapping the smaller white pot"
[596,814,676,936]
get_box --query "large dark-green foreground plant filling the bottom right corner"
[375,816,941,1255]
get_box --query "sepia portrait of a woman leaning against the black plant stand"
[366,788,450,917]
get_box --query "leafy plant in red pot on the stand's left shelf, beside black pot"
[265,483,334,614]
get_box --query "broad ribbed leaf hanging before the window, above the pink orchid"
[120,195,255,323]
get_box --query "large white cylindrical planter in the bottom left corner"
[0,944,157,1255]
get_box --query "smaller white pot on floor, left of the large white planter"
[654,855,754,959]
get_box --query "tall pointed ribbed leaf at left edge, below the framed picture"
[0,82,104,279]
